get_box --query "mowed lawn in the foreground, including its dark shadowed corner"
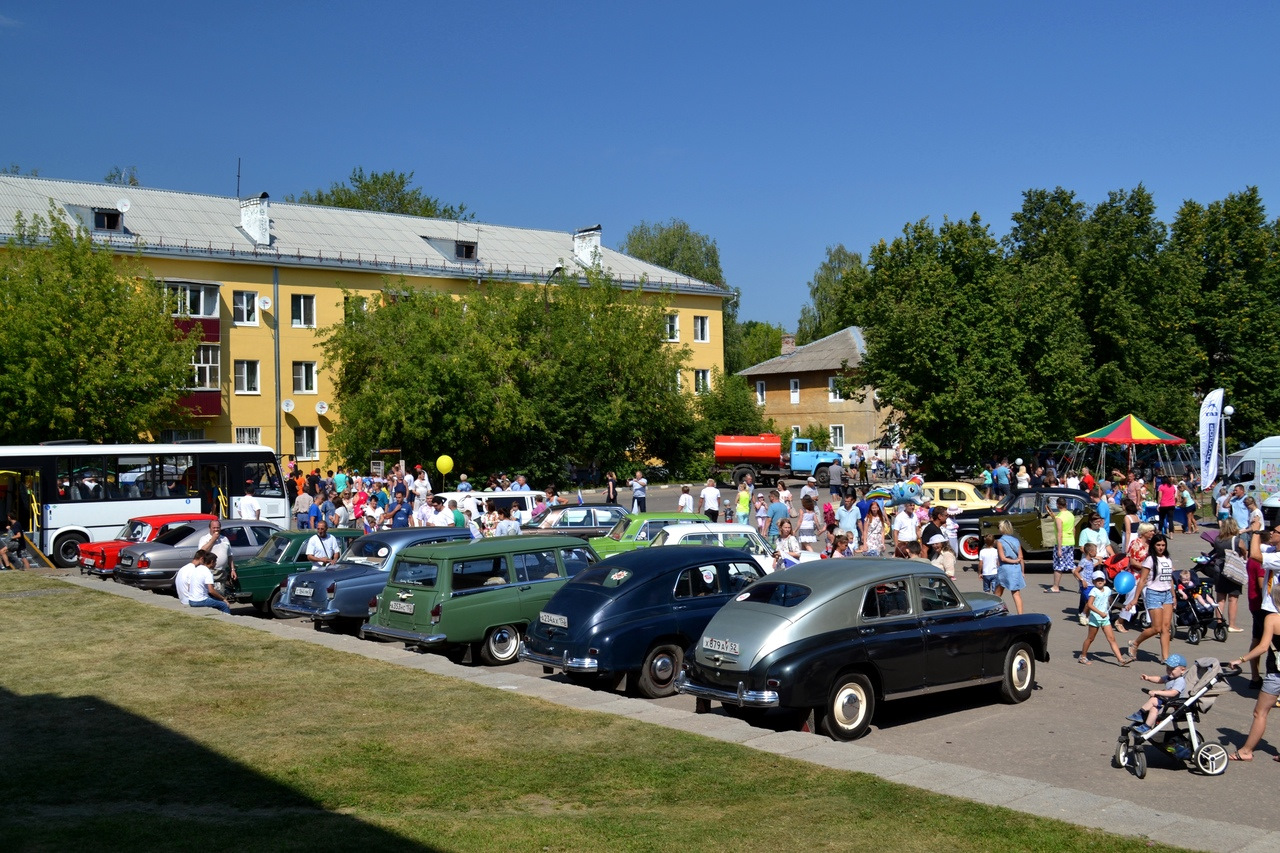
[0,573,1182,852]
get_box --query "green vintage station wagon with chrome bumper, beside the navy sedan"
[364,537,599,665]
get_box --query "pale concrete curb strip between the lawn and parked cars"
[54,575,1280,853]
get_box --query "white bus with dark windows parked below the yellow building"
[0,442,289,569]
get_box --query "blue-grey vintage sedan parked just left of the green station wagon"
[275,528,471,633]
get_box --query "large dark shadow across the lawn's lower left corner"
[0,688,433,850]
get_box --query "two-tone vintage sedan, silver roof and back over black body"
[676,557,1052,740]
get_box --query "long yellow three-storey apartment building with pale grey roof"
[0,175,728,467]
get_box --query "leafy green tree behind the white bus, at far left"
[0,209,197,444]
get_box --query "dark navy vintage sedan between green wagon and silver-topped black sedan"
[520,546,762,699]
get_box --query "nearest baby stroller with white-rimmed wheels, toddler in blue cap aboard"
[1111,657,1240,779]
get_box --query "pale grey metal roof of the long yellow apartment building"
[0,175,728,296]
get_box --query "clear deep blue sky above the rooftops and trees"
[0,0,1280,328]
